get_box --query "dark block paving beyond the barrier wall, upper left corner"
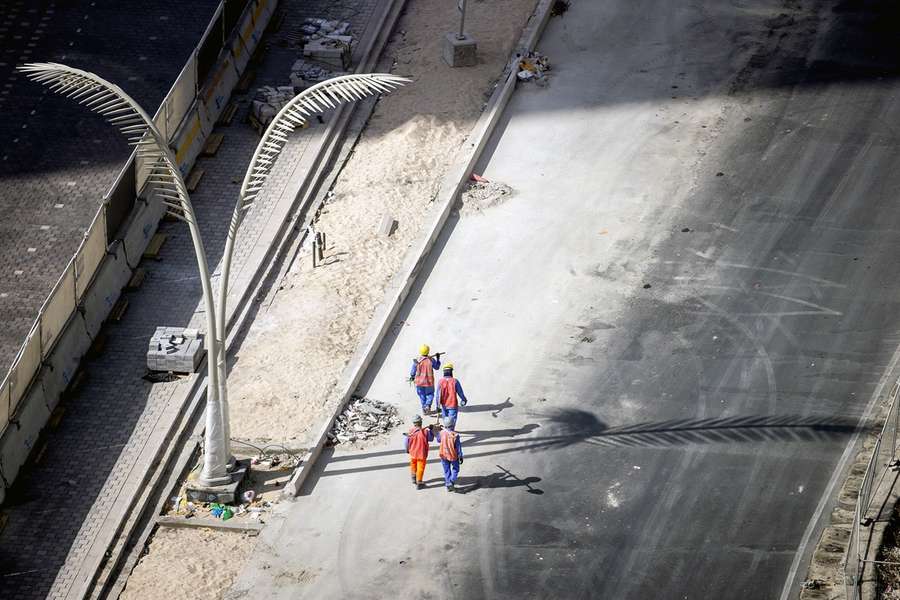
[0,0,218,377]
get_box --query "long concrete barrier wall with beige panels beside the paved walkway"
[0,0,277,504]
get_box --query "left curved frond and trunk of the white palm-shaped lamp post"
[18,63,231,486]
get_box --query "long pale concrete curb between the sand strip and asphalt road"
[283,0,555,497]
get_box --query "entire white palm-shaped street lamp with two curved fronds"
[19,63,407,488]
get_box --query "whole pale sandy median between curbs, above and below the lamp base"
[121,0,535,600]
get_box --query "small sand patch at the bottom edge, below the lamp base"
[119,528,257,600]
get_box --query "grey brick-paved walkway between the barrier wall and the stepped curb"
[0,0,378,598]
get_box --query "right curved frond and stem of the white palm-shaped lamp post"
[216,73,410,440]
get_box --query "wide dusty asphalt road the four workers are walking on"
[232,0,900,599]
